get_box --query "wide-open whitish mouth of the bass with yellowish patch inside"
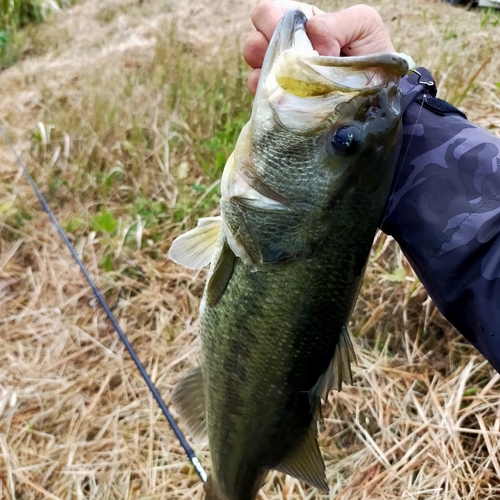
[256,10,415,99]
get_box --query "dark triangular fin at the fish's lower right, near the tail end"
[275,418,329,491]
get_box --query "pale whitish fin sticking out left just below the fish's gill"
[168,216,221,269]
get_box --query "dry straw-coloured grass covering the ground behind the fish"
[0,0,500,500]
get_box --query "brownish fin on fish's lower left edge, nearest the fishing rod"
[171,366,207,443]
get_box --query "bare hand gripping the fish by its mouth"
[243,0,394,95]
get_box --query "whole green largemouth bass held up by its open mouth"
[169,10,413,500]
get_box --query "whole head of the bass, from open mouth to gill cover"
[221,10,413,269]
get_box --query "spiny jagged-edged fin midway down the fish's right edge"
[309,326,356,404]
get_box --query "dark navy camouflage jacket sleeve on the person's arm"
[382,68,500,372]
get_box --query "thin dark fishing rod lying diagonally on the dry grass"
[0,125,207,483]
